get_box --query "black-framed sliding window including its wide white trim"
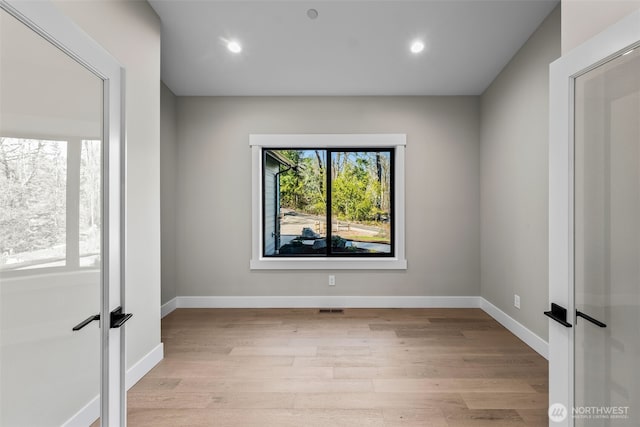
[250,135,406,269]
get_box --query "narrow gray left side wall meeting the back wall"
[160,83,178,304]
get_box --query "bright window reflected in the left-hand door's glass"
[0,137,102,275]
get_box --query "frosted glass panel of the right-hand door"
[574,45,640,426]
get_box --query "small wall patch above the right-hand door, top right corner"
[562,0,640,54]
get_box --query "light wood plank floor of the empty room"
[128,309,548,427]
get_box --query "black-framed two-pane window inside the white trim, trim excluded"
[262,148,394,257]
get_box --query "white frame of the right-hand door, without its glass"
[549,6,640,427]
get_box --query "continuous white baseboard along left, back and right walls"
[162,296,549,359]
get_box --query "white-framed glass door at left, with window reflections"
[0,1,125,427]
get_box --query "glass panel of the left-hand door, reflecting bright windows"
[0,9,103,426]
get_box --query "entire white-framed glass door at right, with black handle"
[548,7,640,426]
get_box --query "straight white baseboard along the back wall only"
[176,296,480,308]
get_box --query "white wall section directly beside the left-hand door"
[55,0,160,367]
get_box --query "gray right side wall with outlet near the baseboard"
[480,7,560,340]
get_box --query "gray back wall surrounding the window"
[177,97,480,296]
